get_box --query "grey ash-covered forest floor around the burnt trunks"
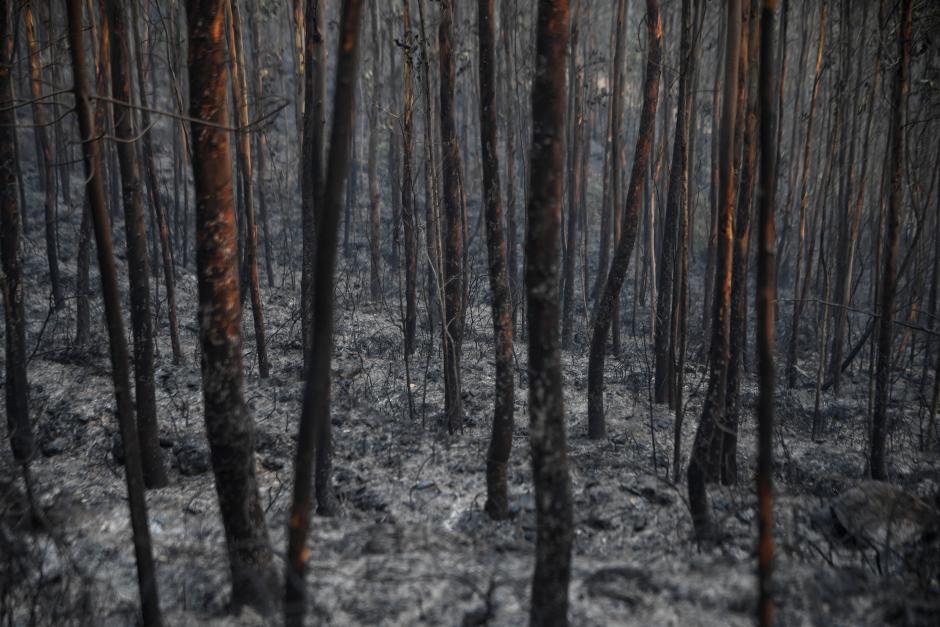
[0,200,940,626]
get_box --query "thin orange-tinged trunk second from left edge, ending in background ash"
[22,8,65,310]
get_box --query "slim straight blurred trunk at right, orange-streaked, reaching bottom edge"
[755,0,786,627]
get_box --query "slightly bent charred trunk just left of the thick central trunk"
[477,0,514,520]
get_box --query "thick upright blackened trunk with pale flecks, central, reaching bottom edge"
[525,0,576,626]
